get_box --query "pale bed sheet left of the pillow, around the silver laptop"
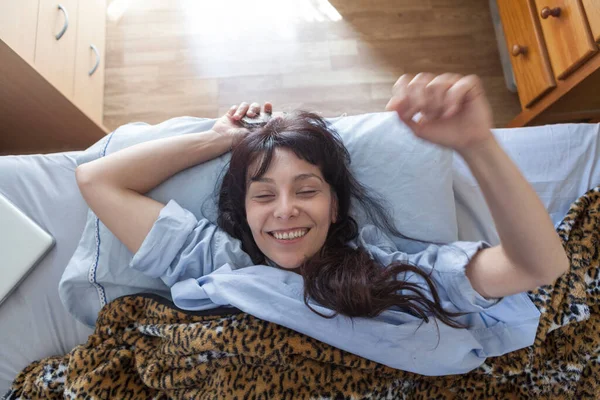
[0,152,92,396]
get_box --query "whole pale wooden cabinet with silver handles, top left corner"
[0,0,107,154]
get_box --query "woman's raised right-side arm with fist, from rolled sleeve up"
[386,74,569,297]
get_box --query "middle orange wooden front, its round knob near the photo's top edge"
[535,0,598,79]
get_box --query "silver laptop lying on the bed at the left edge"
[0,193,55,304]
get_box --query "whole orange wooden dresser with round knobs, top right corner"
[496,0,600,127]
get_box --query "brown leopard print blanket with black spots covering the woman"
[6,187,600,400]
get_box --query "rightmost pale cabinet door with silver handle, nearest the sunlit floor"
[73,0,106,124]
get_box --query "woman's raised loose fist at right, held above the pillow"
[386,73,493,152]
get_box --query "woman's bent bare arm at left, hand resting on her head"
[76,103,270,253]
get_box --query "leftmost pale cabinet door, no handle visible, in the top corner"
[0,0,40,64]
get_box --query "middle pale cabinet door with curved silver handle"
[34,0,79,99]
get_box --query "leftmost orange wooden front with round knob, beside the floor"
[497,0,556,108]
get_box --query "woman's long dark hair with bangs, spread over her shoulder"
[217,111,465,328]
